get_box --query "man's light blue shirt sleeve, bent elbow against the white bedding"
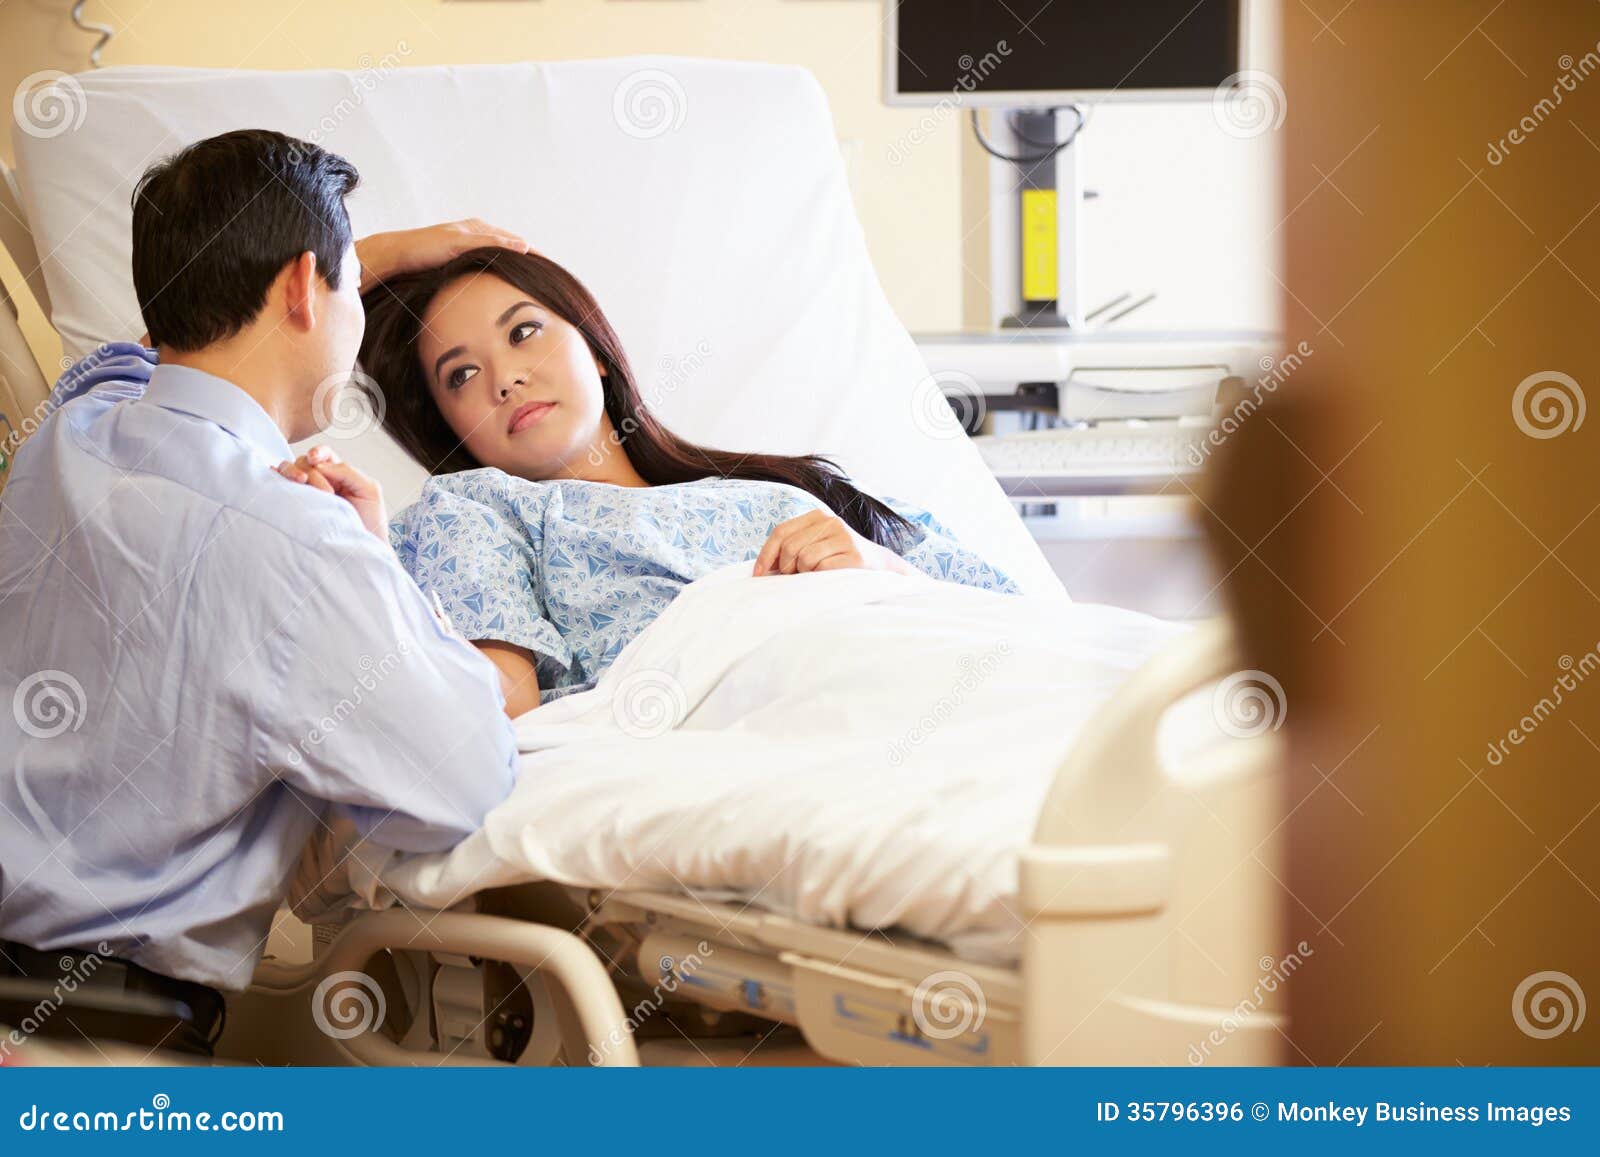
[256,533,517,851]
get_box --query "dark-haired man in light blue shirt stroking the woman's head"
[0,131,526,1051]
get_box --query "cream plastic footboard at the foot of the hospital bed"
[1019,619,1286,1064]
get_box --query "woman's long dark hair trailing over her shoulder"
[362,248,910,549]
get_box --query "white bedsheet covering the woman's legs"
[337,563,1184,962]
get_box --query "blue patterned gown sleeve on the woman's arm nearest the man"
[390,478,573,688]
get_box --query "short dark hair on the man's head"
[133,128,360,352]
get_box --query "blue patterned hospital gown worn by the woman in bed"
[390,469,1018,701]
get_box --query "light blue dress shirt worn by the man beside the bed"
[0,346,515,989]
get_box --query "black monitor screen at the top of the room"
[896,0,1238,96]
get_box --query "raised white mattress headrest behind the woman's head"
[13,58,1061,591]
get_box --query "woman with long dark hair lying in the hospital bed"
[318,248,1016,715]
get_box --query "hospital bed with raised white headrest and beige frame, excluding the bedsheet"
[0,58,1293,1064]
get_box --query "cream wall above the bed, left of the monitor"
[0,0,965,374]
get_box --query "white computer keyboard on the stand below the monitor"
[973,421,1211,498]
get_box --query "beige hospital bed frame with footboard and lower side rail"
[0,165,1298,1066]
